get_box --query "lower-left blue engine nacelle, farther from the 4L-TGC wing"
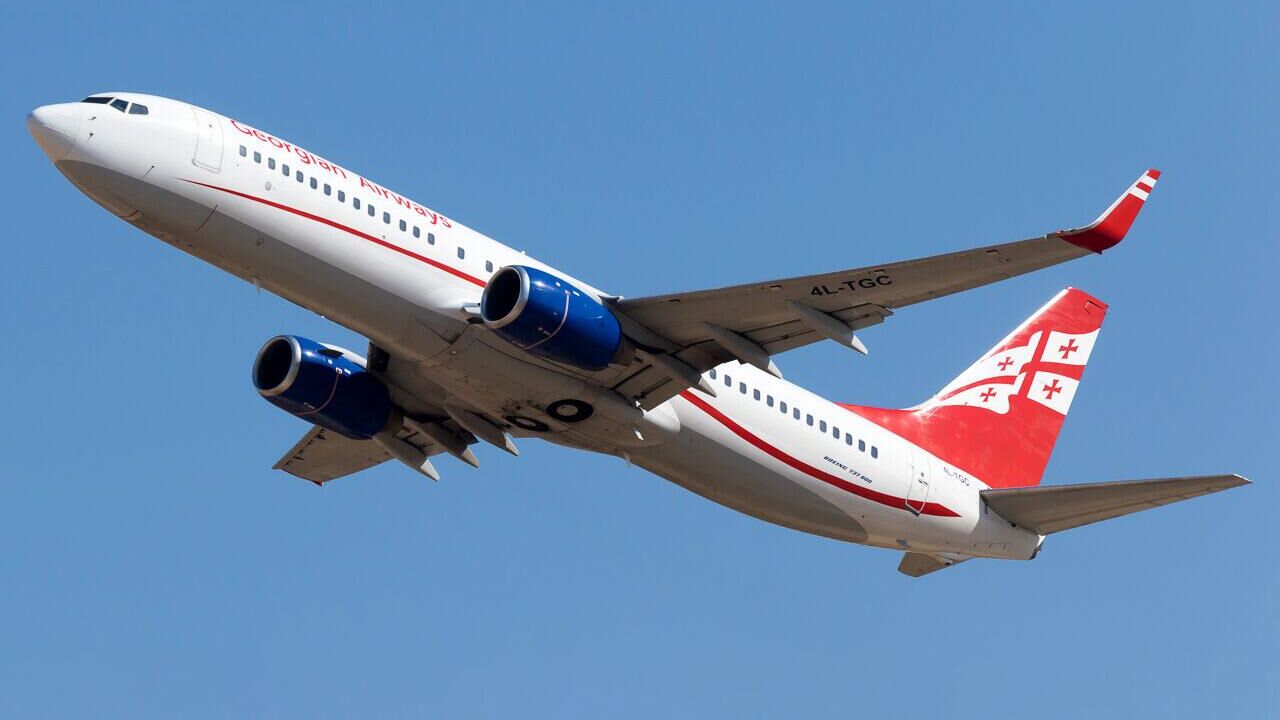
[253,336,394,439]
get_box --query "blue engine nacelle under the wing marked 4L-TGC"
[480,265,623,370]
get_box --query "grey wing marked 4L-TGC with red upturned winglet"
[612,170,1160,407]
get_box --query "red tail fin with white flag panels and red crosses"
[845,288,1107,488]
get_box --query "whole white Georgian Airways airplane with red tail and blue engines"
[27,92,1249,577]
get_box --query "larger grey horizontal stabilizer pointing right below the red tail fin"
[982,475,1249,536]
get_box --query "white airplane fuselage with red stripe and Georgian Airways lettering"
[32,94,1042,559]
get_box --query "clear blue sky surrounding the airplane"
[0,3,1280,717]
